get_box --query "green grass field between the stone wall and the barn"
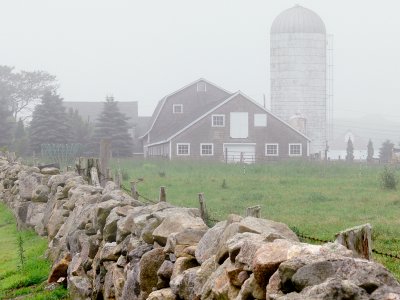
[114,160,400,279]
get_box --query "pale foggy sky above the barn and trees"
[0,0,400,119]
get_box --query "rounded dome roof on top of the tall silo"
[271,5,326,34]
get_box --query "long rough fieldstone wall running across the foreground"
[0,156,400,300]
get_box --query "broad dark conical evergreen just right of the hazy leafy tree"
[29,92,71,152]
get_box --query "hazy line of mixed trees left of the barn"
[0,66,133,156]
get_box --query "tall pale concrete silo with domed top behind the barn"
[271,5,327,157]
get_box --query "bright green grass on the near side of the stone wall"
[0,203,67,300]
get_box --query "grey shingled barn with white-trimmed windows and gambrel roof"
[141,79,310,163]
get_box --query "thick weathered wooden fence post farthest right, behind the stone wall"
[335,224,372,260]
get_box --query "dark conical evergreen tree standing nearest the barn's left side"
[92,97,133,156]
